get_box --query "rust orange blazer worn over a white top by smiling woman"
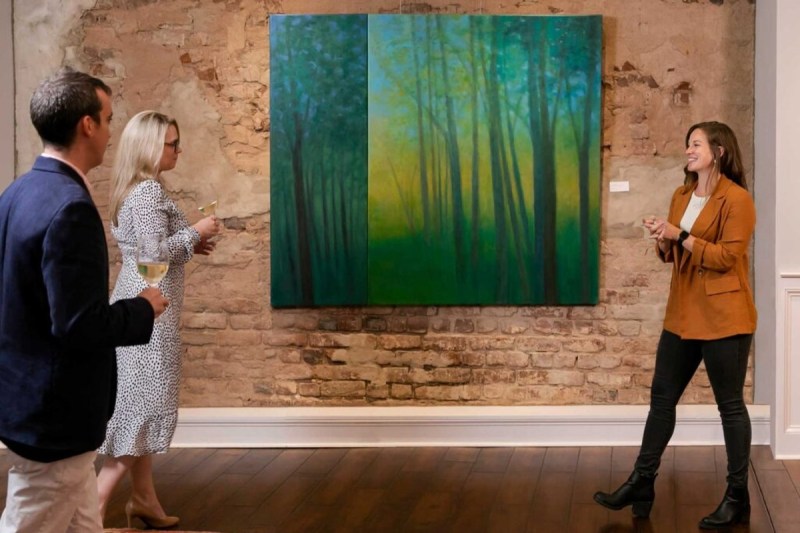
[656,176,756,340]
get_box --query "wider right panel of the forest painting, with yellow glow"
[367,15,602,305]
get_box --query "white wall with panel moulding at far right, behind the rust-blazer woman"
[754,0,800,458]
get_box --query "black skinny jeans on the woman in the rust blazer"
[635,330,753,488]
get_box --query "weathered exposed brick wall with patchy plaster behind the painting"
[15,0,755,406]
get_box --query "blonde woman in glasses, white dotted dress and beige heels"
[97,111,219,527]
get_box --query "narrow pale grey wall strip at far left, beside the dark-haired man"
[0,0,15,192]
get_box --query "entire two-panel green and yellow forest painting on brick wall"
[270,15,601,307]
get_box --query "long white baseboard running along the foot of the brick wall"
[167,405,770,448]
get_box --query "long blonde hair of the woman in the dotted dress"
[109,111,181,226]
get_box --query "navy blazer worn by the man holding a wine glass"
[0,157,153,455]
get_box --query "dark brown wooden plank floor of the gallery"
[0,446,800,533]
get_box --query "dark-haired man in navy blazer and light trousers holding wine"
[0,69,167,533]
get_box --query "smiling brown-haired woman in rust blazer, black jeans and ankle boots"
[594,122,756,529]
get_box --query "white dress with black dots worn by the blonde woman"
[99,179,200,457]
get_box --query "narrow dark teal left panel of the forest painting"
[270,15,367,307]
